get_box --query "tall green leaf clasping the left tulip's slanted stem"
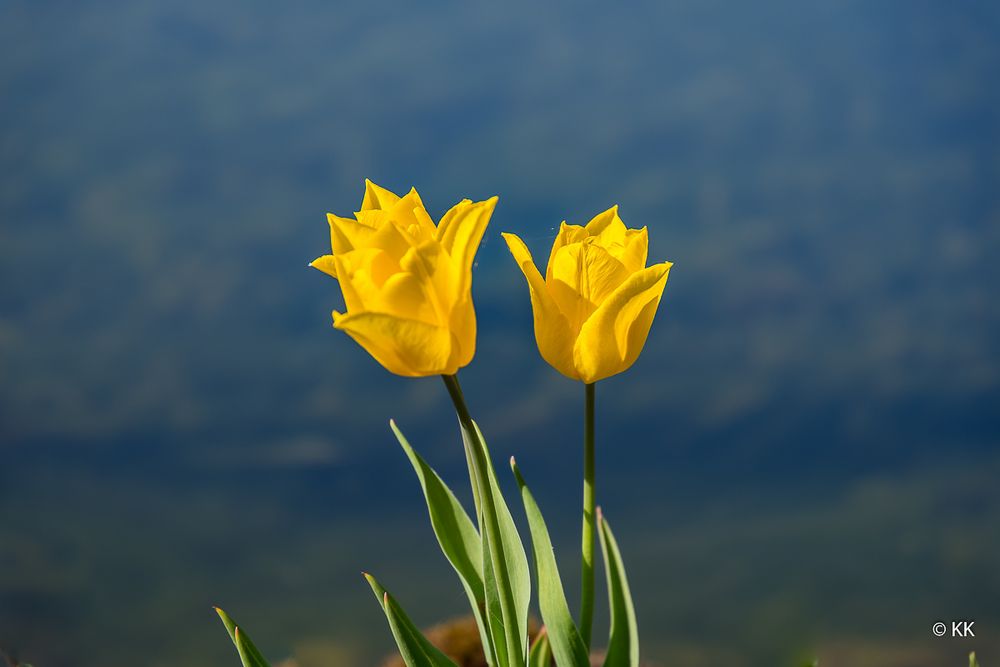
[462,422,531,667]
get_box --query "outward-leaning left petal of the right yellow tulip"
[502,234,580,380]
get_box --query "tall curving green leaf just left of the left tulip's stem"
[389,421,496,665]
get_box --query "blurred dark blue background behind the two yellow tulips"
[0,0,1000,667]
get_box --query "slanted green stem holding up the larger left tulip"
[441,375,524,667]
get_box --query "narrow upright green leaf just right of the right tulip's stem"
[597,508,639,667]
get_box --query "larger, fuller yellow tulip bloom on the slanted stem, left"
[310,181,497,377]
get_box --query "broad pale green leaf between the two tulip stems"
[510,458,590,667]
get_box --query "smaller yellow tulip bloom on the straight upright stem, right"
[503,206,672,384]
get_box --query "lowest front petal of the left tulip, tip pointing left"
[333,311,458,377]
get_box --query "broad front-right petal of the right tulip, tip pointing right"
[573,262,672,383]
